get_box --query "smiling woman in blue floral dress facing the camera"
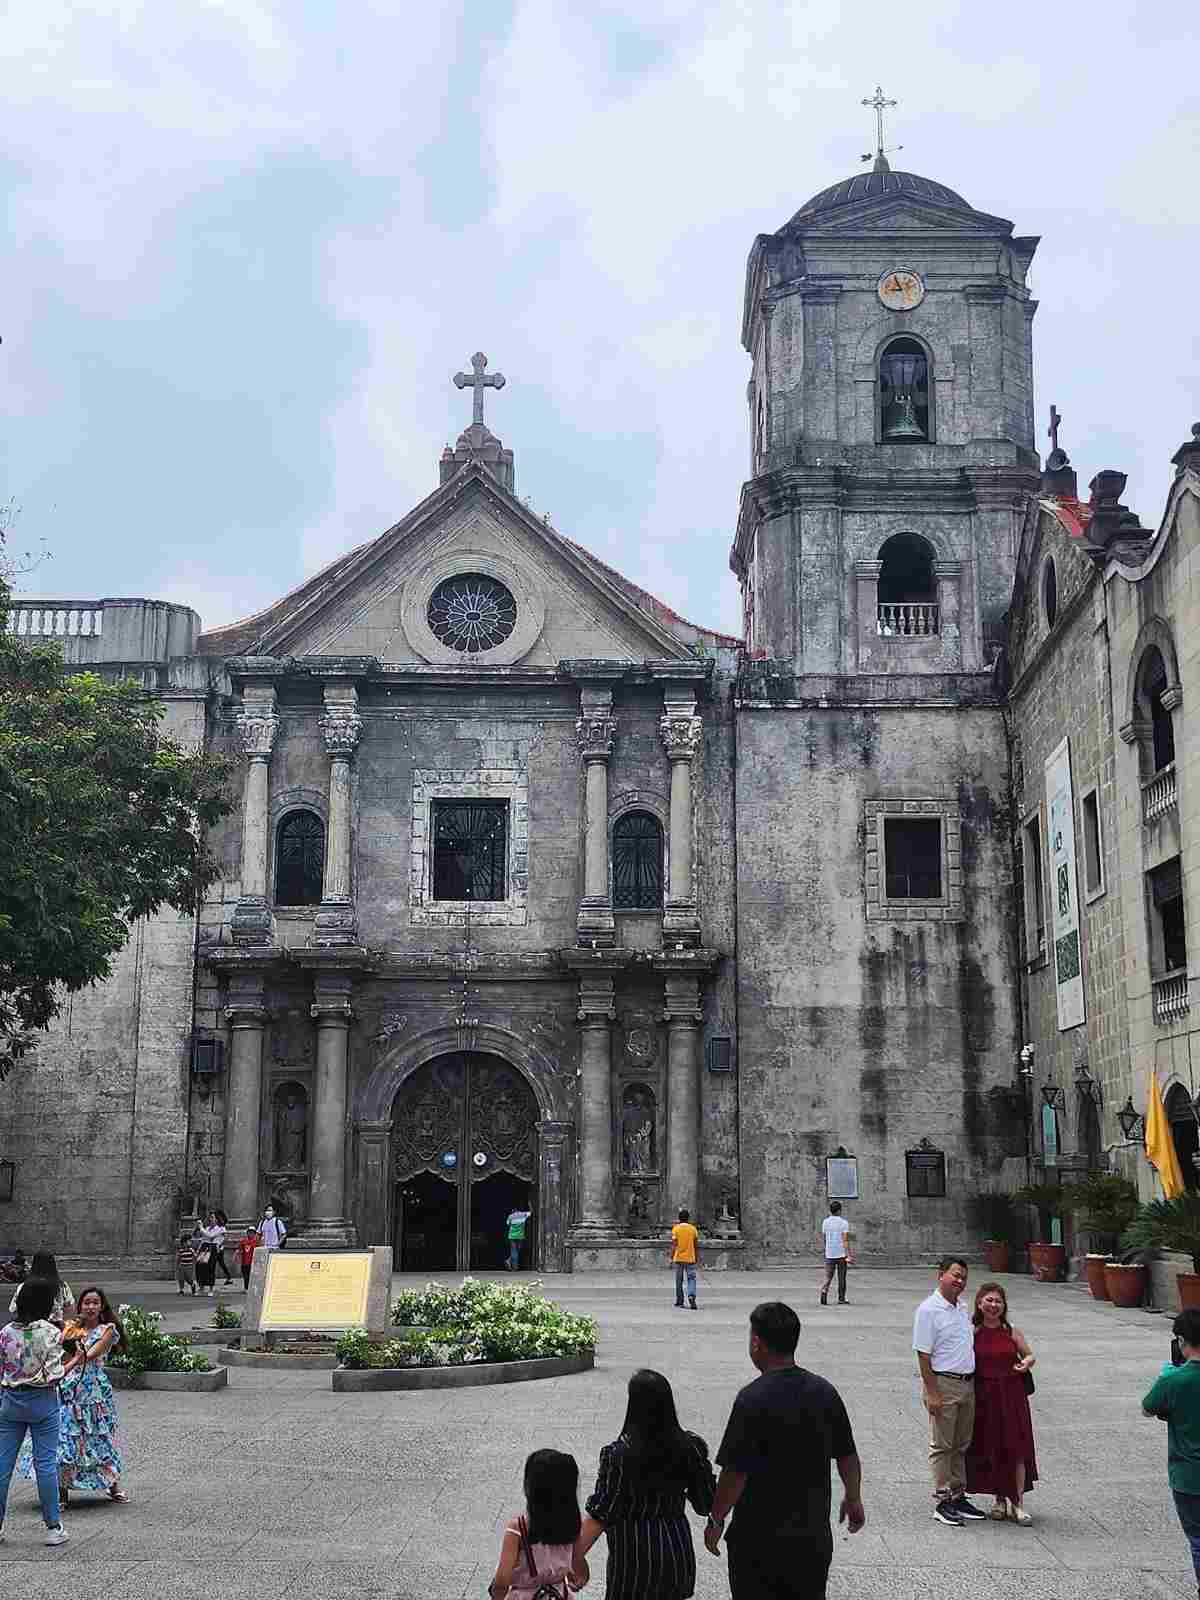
[18,1286,128,1506]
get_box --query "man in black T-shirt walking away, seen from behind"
[704,1301,867,1600]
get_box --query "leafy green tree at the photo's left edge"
[0,563,230,1078]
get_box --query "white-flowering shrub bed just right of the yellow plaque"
[336,1278,595,1371]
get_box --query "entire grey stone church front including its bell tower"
[0,158,1196,1270]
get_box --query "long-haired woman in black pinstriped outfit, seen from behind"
[576,1370,717,1600]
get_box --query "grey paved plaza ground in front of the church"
[0,1269,1195,1600]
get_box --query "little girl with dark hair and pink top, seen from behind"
[488,1450,592,1600]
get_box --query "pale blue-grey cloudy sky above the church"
[0,0,1200,630]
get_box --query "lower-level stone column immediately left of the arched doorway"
[298,973,355,1248]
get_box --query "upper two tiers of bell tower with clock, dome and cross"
[730,128,1038,677]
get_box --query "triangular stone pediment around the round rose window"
[202,462,702,667]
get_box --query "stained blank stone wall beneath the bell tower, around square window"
[736,675,1018,1259]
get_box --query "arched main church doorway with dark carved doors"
[392,1053,538,1272]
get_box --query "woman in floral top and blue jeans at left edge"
[0,1278,67,1544]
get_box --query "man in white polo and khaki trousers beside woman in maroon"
[912,1256,987,1528]
